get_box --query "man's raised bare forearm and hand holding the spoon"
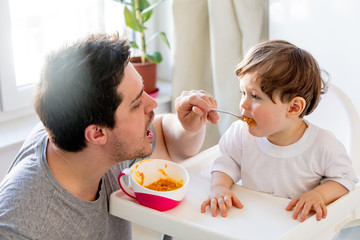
[156,90,219,161]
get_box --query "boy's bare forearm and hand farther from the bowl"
[286,180,349,222]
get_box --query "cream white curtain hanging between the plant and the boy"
[173,0,268,149]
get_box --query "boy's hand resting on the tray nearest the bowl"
[201,186,244,217]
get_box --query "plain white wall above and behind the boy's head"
[269,0,360,116]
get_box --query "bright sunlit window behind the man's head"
[0,0,124,121]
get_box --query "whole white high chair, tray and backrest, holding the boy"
[110,85,360,240]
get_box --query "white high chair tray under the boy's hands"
[110,146,360,240]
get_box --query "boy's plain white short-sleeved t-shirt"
[212,121,358,198]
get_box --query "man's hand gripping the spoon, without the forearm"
[175,90,219,133]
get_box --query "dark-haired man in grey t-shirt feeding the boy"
[0,32,219,239]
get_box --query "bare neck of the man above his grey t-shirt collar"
[46,142,111,201]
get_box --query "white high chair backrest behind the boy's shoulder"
[305,84,360,175]
